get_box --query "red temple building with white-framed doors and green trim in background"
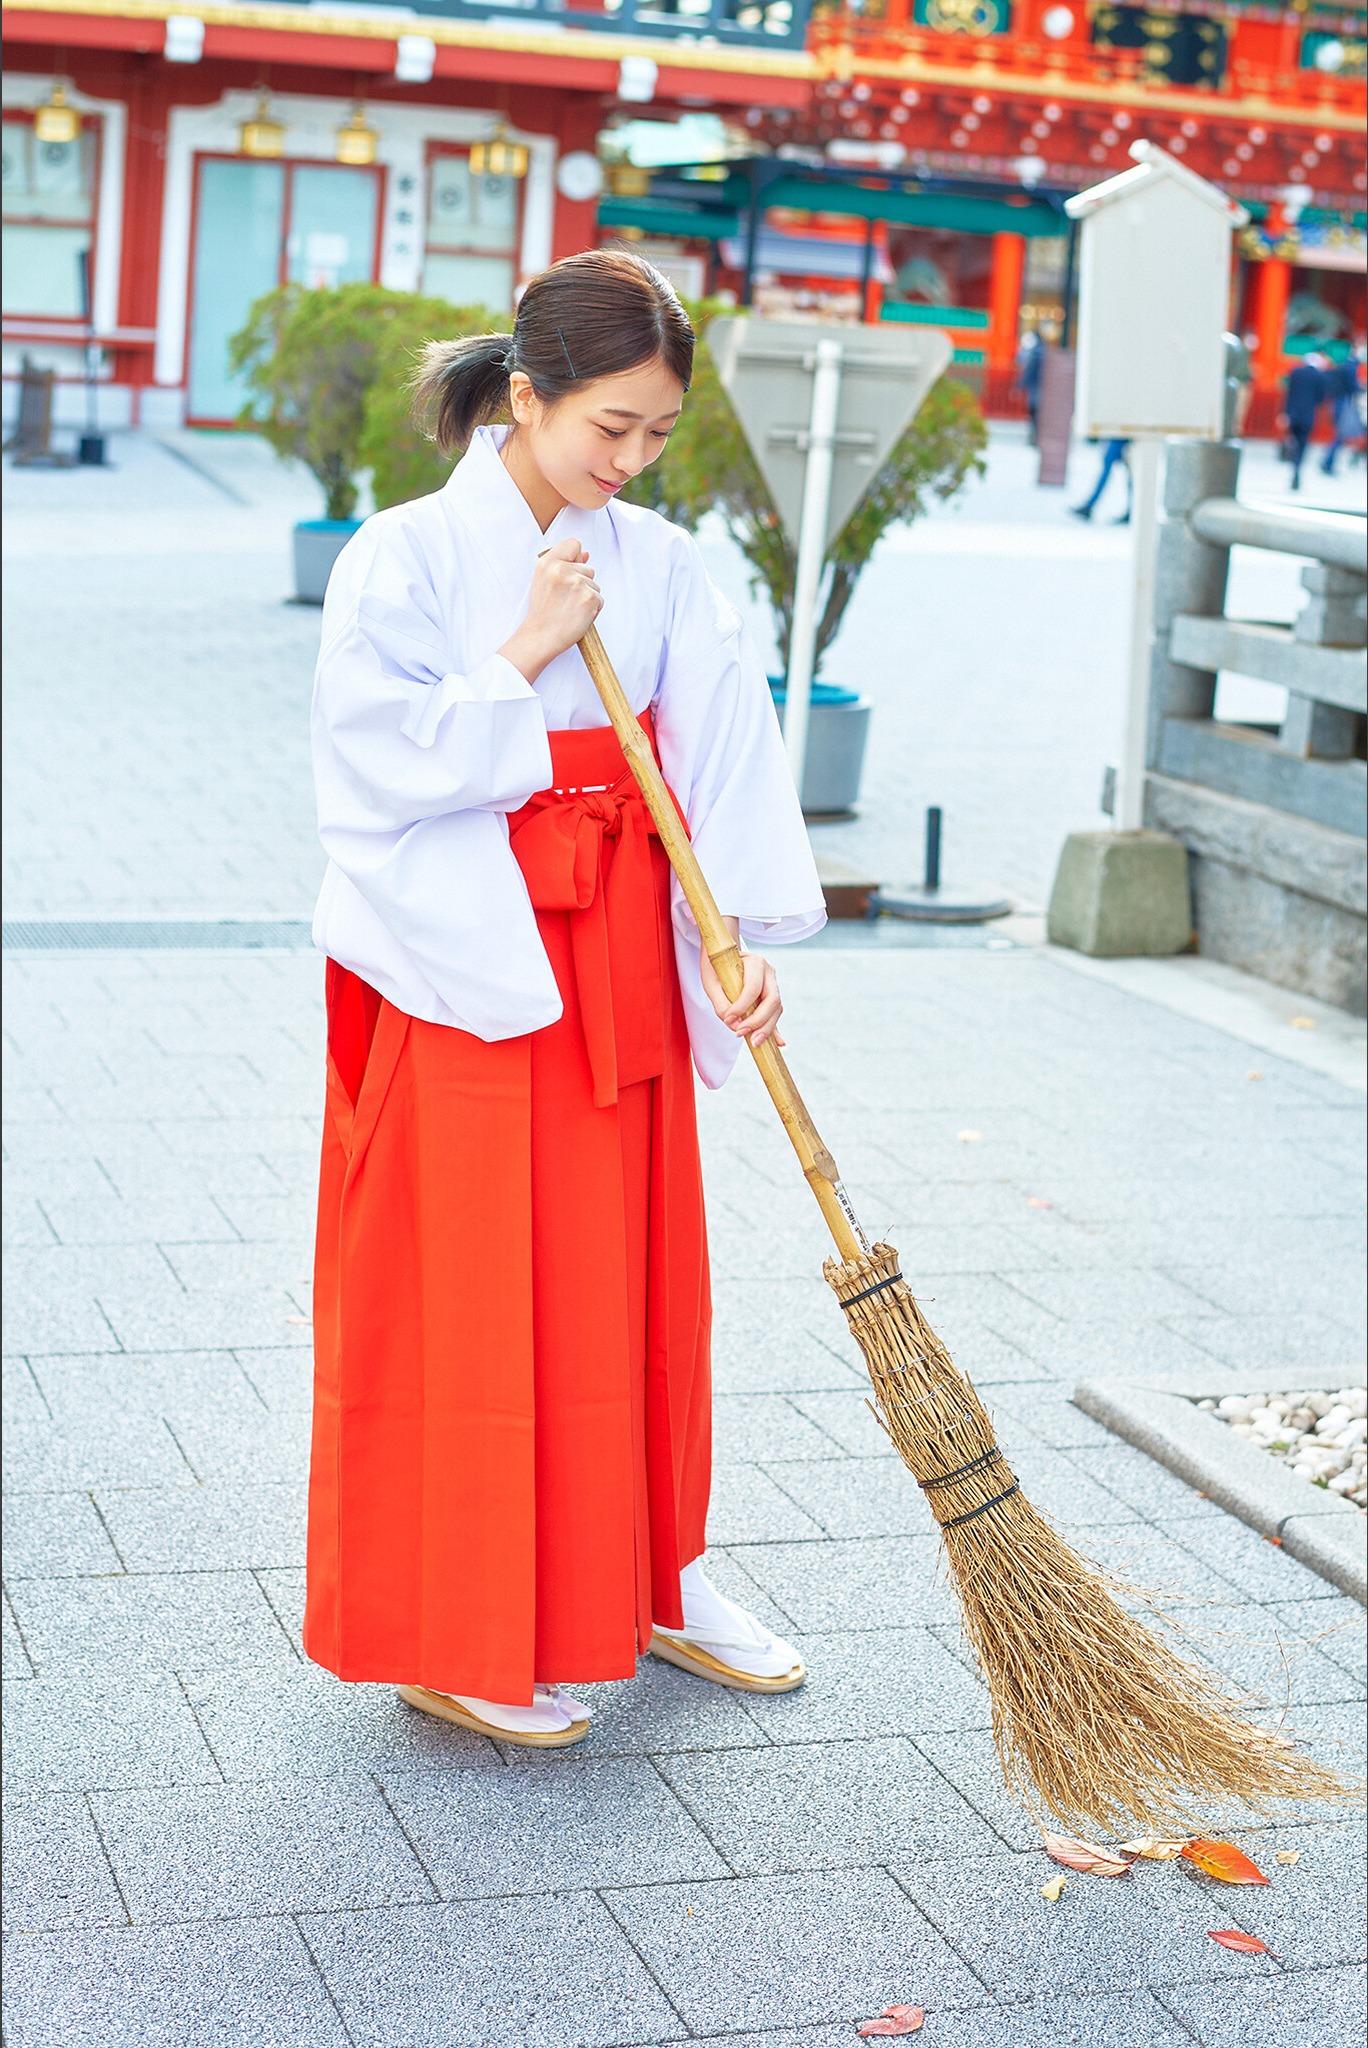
[4,0,1368,432]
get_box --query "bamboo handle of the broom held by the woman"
[580,627,868,1260]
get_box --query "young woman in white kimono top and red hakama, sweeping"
[303,250,825,1747]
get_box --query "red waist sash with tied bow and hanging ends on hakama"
[508,711,678,1110]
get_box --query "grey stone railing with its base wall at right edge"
[1145,442,1368,1012]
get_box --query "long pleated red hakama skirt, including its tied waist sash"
[303,715,711,1704]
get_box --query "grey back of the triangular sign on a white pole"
[707,313,950,551]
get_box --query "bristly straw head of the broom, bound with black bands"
[823,1245,1360,1831]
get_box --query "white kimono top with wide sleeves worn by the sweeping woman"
[311,426,825,1087]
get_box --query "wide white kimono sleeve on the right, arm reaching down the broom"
[655,528,827,1087]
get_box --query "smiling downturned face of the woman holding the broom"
[510,360,684,512]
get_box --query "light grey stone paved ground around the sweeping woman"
[4,423,1364,2048]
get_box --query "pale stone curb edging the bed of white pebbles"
[1073,1366,1368,1606]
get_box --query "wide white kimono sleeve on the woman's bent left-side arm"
[311,508,561,1038]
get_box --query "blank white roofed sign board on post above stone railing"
[1065,143,1247,440]
